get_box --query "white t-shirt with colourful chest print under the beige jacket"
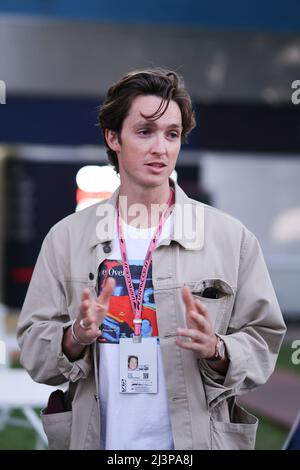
[98,215,174,450]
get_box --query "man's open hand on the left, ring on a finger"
[74,277,116,343]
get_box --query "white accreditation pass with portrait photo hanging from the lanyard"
[120,337,157,393]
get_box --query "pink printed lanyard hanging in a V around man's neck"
[117,188,174,336]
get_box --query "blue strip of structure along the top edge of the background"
[0,0,300,33]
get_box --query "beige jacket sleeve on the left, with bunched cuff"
[17,231,91,385]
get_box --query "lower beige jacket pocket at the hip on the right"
[210,402,258,450]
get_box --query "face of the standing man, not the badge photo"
[108,95,182,188]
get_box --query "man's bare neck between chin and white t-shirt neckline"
[119,182,170,228]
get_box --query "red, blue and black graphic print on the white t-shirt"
[98,259,158,344]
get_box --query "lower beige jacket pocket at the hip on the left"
[41,411,72,450]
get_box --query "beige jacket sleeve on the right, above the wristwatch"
[200,231,286,407]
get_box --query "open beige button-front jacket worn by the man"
[18,185,285,450]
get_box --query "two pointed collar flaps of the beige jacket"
[90,183,204,250]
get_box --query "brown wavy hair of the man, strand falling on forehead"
[98,68,196,173]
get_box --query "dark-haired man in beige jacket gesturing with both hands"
[18,69,285,449]
